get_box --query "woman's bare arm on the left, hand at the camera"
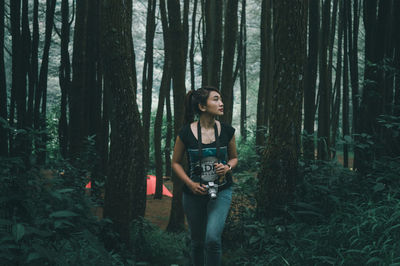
[172,136,207,195]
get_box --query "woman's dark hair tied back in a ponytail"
[185,86,221,124]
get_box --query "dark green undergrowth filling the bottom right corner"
[224,158,400,265]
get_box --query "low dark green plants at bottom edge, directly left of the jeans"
[131,219,189,265]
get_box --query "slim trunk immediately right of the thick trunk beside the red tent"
[142,0,156,170]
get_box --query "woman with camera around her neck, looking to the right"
[172,87,238,266]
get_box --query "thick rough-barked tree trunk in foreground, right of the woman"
[257,0,307,217]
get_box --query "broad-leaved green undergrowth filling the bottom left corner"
[0,158,130,265]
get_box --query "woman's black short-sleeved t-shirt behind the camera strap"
[179,123,235,193]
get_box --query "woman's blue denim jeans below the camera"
[183,187,232,266]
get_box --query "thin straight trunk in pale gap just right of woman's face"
[241,0,247,141]
